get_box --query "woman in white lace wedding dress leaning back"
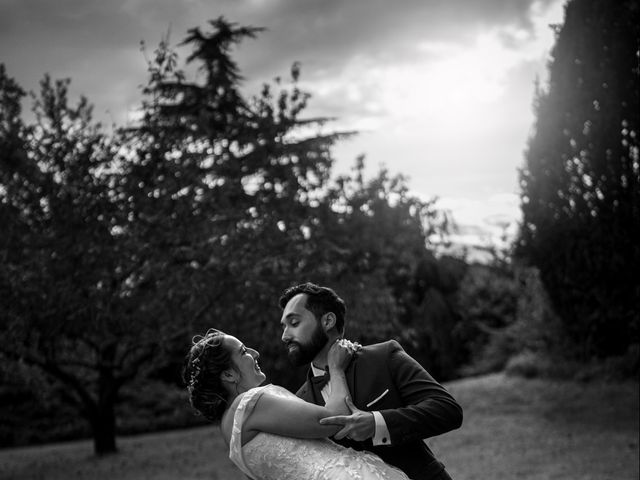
[184,329,408,480]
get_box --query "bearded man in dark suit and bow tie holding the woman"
[280,283,462,480]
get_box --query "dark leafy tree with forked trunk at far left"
[0,68,146,453]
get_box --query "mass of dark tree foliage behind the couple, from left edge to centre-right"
[0,18,461,454]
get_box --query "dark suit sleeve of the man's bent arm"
[380,340,462,446]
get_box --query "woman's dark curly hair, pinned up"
[182,328,233,423]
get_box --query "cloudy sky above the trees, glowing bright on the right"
[0,0,565,255]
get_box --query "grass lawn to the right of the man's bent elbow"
[429,374,640,480]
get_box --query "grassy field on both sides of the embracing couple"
[0,374,639,480]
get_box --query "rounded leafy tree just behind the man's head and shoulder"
[292,157,462,379]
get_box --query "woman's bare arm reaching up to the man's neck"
[244,342,351,438]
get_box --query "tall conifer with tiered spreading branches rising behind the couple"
[127,18,360,381]
